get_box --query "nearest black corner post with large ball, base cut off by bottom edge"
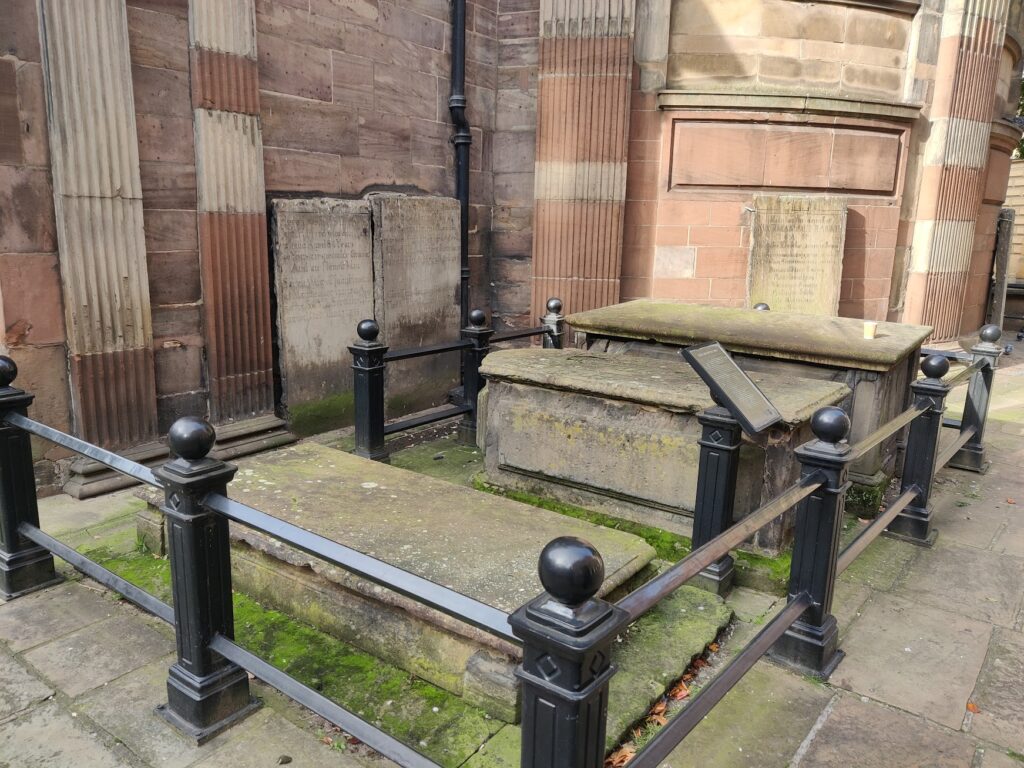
[509,537,629,768]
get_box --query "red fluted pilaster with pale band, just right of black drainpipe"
[532,0,634,316]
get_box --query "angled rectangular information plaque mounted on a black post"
[681,341,782,435]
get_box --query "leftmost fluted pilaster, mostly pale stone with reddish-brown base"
[40,0,157,447]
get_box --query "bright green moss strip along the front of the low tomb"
[88,550,504,768]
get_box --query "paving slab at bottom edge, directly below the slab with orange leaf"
[794,694,975,768]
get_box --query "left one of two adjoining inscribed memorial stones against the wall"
[270,199,374,433]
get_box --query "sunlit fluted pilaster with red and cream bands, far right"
[903,0,1009,339]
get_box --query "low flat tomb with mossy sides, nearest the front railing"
[139,442,654,722]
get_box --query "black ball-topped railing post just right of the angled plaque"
[769,406,851,678]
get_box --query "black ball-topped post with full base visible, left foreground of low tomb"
[156,417,259,743]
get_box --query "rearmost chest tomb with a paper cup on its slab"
[568,299,932,485]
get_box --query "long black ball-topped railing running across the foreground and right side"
[0,327,1001,768]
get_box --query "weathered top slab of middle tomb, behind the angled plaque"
[480,349,850,426]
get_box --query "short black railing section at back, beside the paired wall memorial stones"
[348,298,565,461]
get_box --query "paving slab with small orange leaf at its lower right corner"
[830,593,991,730]
